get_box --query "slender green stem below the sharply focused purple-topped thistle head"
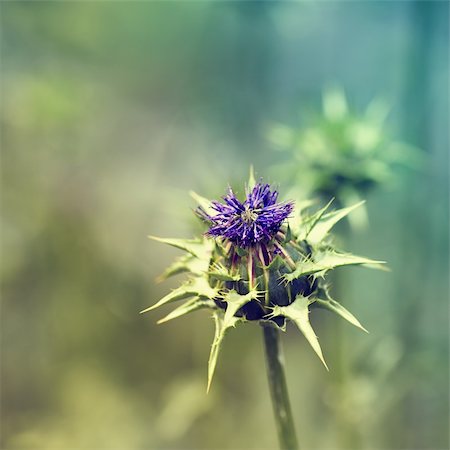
[263,324,298,450]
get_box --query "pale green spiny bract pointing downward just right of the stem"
[272,295,328,370]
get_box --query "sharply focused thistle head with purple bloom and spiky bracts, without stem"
[142,173,382,390]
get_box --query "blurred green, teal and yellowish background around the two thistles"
[1,1,449,450]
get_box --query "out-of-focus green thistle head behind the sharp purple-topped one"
[267,86,424,227]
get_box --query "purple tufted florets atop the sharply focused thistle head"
[197,183,294,248]
